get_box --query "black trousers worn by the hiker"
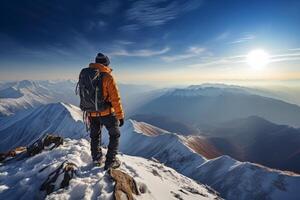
[90,114,120,161]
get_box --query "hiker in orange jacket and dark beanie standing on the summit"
[78,53,124,170]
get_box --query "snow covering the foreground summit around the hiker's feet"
[0,139,221,200]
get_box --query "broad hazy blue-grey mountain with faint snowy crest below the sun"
[135,85,300,129]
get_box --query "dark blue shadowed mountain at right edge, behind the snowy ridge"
[205,116,300,173]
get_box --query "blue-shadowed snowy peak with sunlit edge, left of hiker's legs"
[0,103,87,151]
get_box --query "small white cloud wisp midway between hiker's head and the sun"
[161,47,206,62]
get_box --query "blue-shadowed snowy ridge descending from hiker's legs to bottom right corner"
[104,121,300,200]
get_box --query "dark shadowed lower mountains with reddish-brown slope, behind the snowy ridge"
[133,115,300,173]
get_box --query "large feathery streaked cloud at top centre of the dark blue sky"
[126,0,203,26]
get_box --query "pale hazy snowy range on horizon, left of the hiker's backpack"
[0,80,79,116]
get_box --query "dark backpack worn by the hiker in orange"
[76,67,111,112]
